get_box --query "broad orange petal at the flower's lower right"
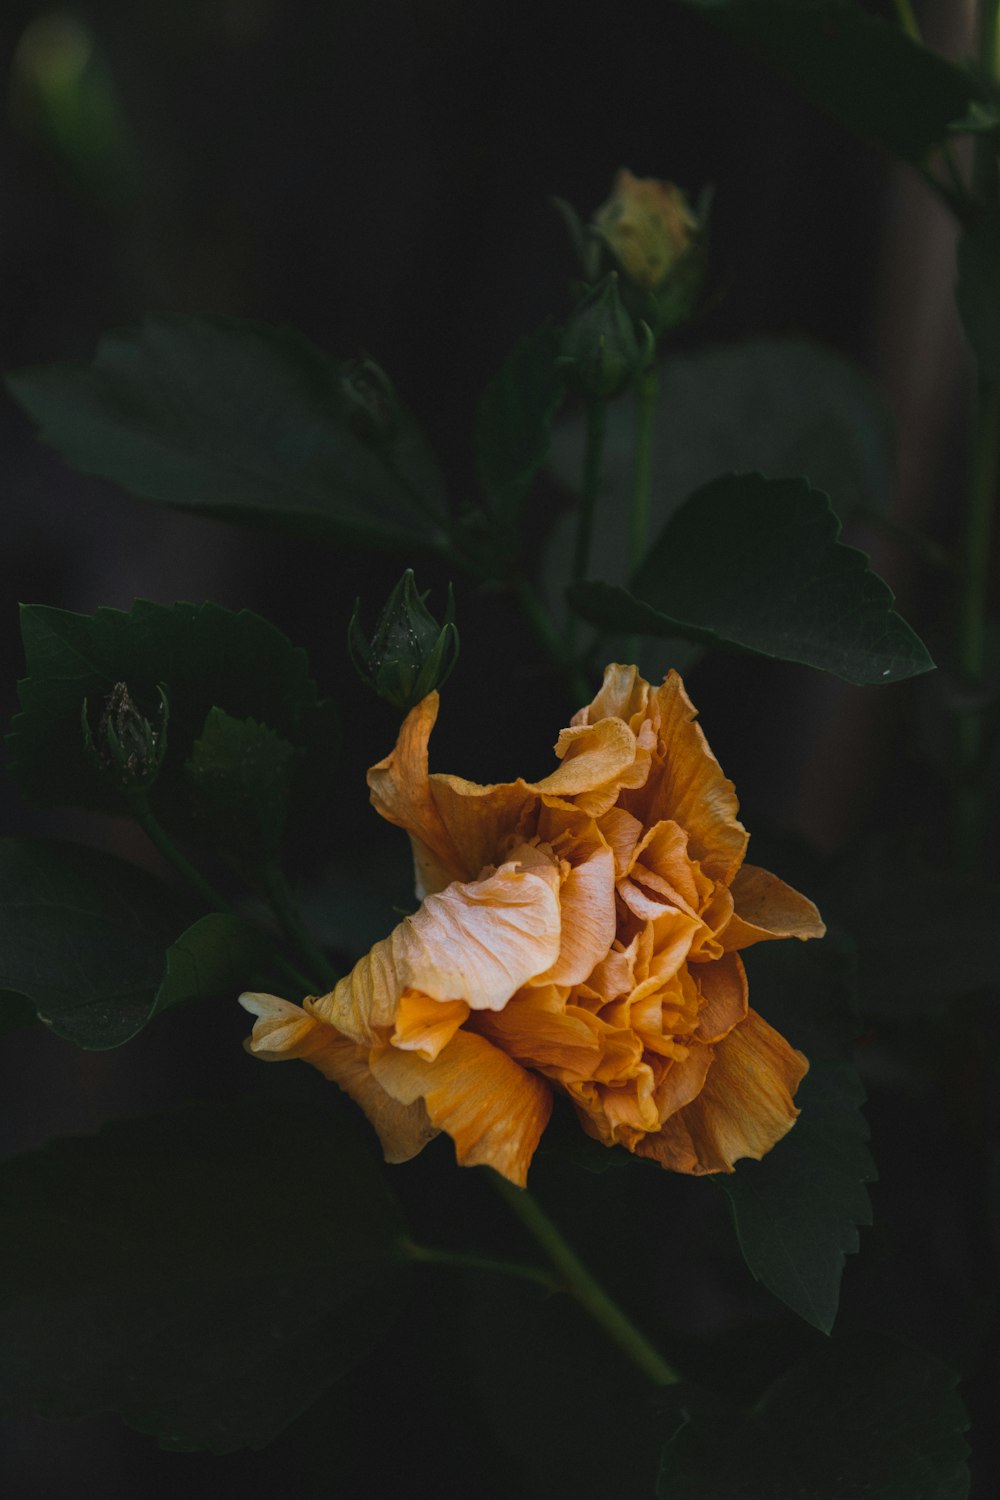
[636,1011,808,1176]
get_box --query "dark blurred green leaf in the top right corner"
[684,0,984,164]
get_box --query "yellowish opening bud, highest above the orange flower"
[594,167,699,291]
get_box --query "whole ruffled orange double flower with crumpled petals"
[241,666,825,1185]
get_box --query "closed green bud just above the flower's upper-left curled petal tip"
[348,569,459,714]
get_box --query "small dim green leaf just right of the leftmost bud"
[186,708,298,866]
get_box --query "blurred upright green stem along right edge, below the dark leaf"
[955,383,1000,872]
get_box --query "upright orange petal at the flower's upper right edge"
[638,672,748,885]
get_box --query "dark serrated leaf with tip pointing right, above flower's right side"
[568,474,934,684]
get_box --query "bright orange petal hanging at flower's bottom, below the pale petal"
[372,1031,552,1188]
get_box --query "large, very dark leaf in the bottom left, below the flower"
[0,1089,406,1454]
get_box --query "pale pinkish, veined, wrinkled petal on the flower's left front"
[309,864,561,1044]
